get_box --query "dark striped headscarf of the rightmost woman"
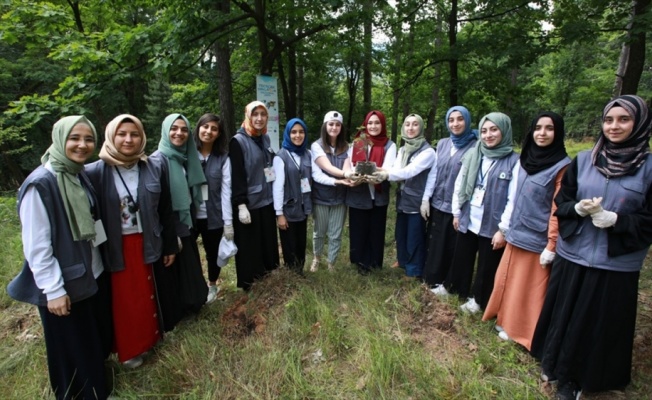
[591,95,652,178]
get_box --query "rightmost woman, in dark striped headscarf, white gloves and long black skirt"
[532,95,652,399]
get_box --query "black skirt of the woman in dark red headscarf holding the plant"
[349,206,387,270]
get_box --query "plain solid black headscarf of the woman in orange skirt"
[521,111,568,175]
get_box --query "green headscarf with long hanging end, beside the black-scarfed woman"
[459,112,514,205]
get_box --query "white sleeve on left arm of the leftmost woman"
[19,186,66,301]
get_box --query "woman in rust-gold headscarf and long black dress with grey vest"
[229,101,279,291]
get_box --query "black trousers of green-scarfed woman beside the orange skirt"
[447,231,505,310]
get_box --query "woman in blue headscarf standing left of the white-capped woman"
[273,118,312,274]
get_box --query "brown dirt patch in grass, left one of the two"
[221,268,302,340]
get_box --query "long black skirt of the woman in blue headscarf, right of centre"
[423,207,457,287]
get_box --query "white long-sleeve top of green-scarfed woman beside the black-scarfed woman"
[451,157,520,234]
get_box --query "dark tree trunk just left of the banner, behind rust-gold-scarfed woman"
[213,0,236,138]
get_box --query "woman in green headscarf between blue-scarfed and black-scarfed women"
[447,112,519,313]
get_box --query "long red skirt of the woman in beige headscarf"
[111,233,161,362]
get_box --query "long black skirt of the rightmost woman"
[532,257,640,392]
